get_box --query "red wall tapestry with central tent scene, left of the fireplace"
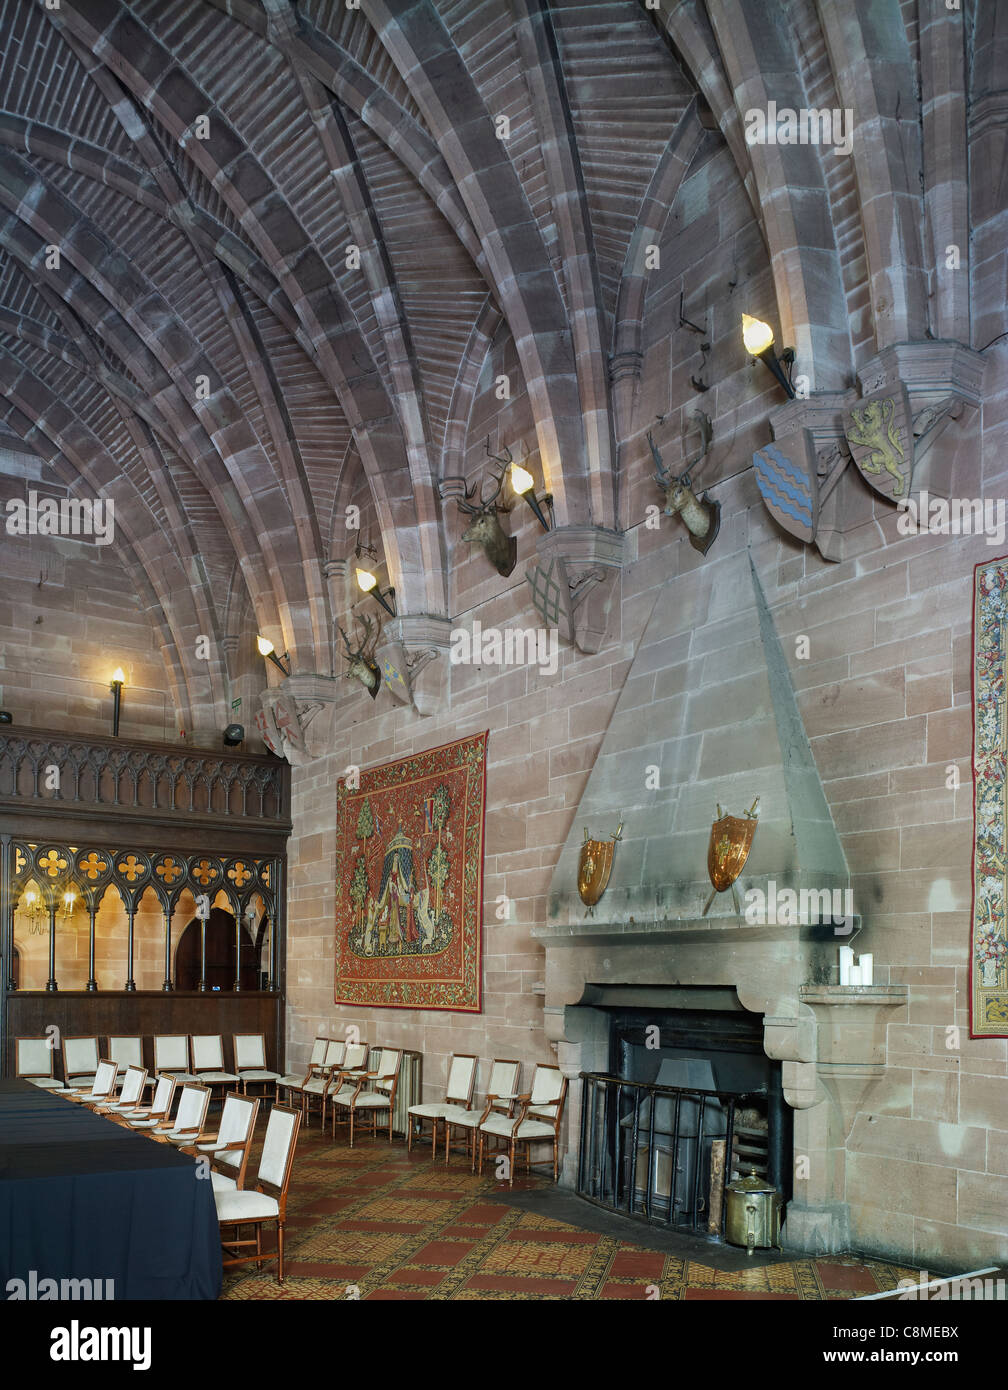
[335,734,487,1013]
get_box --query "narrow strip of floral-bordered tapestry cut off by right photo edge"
[969,556,1008,1038]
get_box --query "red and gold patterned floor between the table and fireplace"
[222,1122,915,1300]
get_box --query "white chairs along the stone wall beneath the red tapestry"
[278,1037,567,1184]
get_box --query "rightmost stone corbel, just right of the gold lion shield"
[858,341,986,499]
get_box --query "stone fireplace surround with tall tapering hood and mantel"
[534,553,907,1252]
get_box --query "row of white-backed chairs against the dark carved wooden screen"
[15,1033,279,1095]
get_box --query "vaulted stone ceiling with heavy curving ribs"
[0,0,1000,730]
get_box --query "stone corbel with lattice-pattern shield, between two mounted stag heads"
[526,525,623,652]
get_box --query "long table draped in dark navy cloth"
[0,1081,221,1298]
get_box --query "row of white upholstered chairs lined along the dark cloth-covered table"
[56,1062,300,1284]
